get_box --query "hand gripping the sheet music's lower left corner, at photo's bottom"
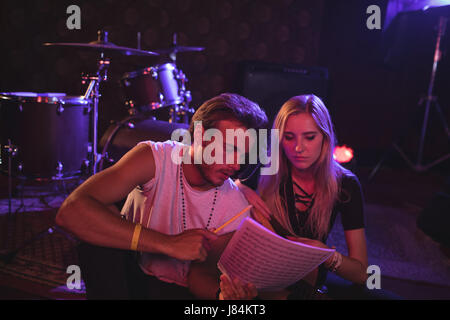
[219,274,258,300]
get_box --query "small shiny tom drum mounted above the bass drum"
[121,63,189,114]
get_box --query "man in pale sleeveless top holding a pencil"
[56,94,267,299]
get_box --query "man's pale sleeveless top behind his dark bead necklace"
[122,141,249,286]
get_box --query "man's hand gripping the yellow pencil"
[167,229,218,262]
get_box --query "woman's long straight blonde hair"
[258,95,351,239]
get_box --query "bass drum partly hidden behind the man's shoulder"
[98,115,189,171]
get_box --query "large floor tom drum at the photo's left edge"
[0,92,90,178]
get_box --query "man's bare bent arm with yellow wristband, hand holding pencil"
[56,144,216,261]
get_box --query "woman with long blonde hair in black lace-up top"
[219,95,368,299]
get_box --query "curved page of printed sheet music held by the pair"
[217,217,335,290]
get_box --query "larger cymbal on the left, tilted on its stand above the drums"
[44,40,159,56]
